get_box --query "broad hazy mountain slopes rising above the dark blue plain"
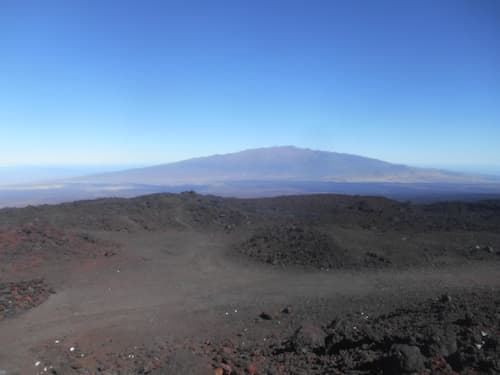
[70,146,487,186]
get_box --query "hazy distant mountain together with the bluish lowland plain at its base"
[0,146,500,207]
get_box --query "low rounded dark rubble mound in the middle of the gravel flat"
[239,225,349,269]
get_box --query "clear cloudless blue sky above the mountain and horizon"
[0,0,500,171]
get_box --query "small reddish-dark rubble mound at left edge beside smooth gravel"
[0,279,53,321]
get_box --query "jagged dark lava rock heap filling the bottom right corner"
[205,291,500,375]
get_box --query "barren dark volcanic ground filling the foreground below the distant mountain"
[0,192,500,375]
